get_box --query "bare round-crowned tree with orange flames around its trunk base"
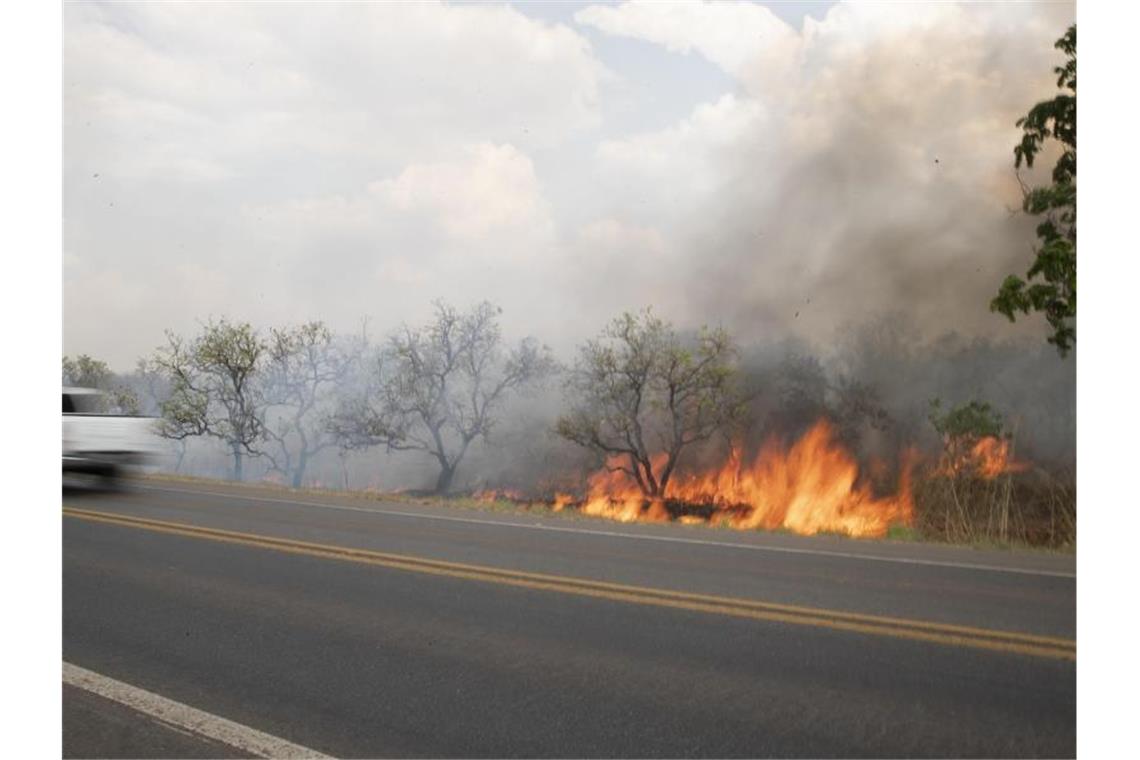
[555,309,744,498]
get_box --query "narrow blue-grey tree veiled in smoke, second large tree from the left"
[261,321,364,488]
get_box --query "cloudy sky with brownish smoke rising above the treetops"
[63,1,1075,370]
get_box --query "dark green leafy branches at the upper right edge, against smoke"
[990,25,1076,356]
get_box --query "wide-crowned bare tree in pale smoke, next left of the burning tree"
[333,302,555,493]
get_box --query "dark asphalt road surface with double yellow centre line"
[63,481,1076,757]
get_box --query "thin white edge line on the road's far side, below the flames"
[139,484,1076,579]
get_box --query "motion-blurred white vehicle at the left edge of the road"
[63,387,154,480]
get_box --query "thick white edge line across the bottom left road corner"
[64,662,331,758]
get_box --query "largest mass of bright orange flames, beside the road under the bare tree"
[581,420,914,537]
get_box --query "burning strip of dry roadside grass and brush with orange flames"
[475,420,1076,548]
